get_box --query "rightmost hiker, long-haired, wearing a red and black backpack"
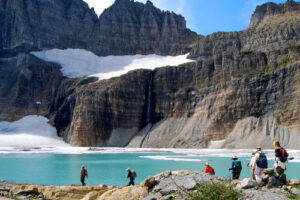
[273,140,288,175]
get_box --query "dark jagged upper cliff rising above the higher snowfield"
[0,0,196,57]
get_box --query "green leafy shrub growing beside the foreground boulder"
[180,183,241,200]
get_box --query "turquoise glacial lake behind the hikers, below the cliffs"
[0,150,300,185]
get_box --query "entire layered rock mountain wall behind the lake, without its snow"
[0,0,300,148]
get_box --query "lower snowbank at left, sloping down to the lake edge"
[0,115,69,147]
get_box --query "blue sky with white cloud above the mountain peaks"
[85,0,299,35]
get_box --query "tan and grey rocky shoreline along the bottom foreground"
[0,171,300,200]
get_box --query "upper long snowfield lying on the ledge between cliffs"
[31,49,194,80]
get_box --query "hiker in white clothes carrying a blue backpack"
[252,147,268,183]
